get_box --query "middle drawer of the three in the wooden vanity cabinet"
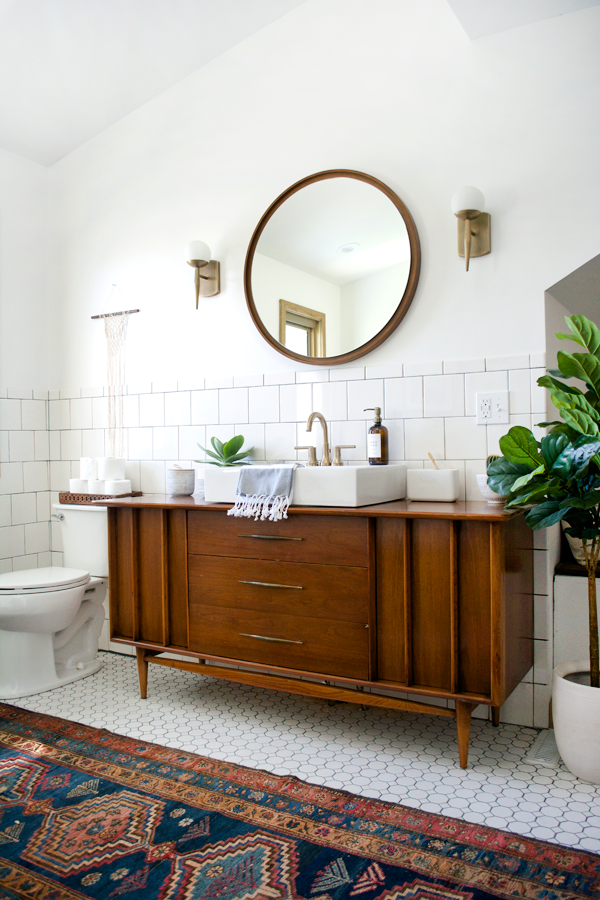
[188,555,369,625]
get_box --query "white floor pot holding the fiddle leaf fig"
[552,660,600,784]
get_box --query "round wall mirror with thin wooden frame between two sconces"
[244,169,421,365]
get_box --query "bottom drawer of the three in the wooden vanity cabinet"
[190,604,369,679]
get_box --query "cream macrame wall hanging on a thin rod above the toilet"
[92,284,139,458]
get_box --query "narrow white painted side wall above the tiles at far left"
[0,150,48,386]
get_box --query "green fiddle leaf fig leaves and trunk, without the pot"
[487,316,600,687]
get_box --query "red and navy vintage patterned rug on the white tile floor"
[0,703,600,900]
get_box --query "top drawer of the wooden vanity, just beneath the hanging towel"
[188,510,369,566]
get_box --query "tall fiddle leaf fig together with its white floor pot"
[488,316,600,784]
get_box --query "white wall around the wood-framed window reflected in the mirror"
[252,253,341,356]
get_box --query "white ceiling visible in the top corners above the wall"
[0,0,600,165]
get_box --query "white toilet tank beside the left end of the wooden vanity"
[53,503,108,578]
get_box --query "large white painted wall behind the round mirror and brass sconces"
[41,0,600,386]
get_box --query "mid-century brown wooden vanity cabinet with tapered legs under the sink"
[109,495,533,766]
